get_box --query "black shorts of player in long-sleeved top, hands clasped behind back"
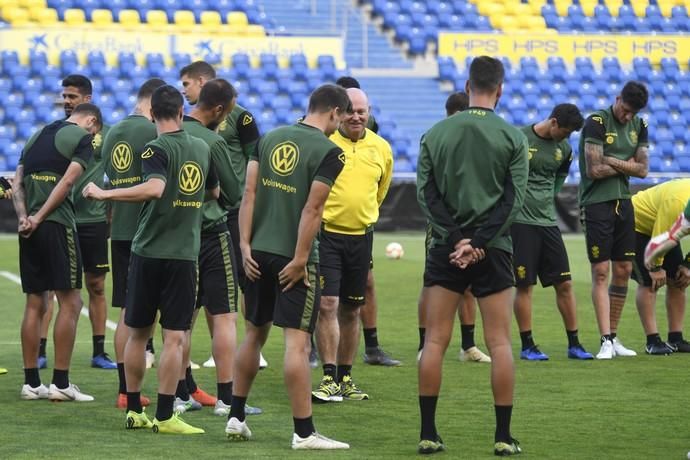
[424,245,515,298]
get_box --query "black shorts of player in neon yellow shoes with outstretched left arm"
[125,253,197,331]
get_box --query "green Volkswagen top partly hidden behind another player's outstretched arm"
[103,115,157,241]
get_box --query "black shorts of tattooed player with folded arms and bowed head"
[580,200,635,263]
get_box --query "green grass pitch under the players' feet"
[0,234,690,459]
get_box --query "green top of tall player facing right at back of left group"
[218,105,259,209]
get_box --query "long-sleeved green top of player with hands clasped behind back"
[417,107,529,253]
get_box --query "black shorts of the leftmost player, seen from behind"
[19,221,82,294]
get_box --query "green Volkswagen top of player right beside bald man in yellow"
[250,123,345,262]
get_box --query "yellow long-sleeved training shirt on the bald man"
[323,129,393,235]
